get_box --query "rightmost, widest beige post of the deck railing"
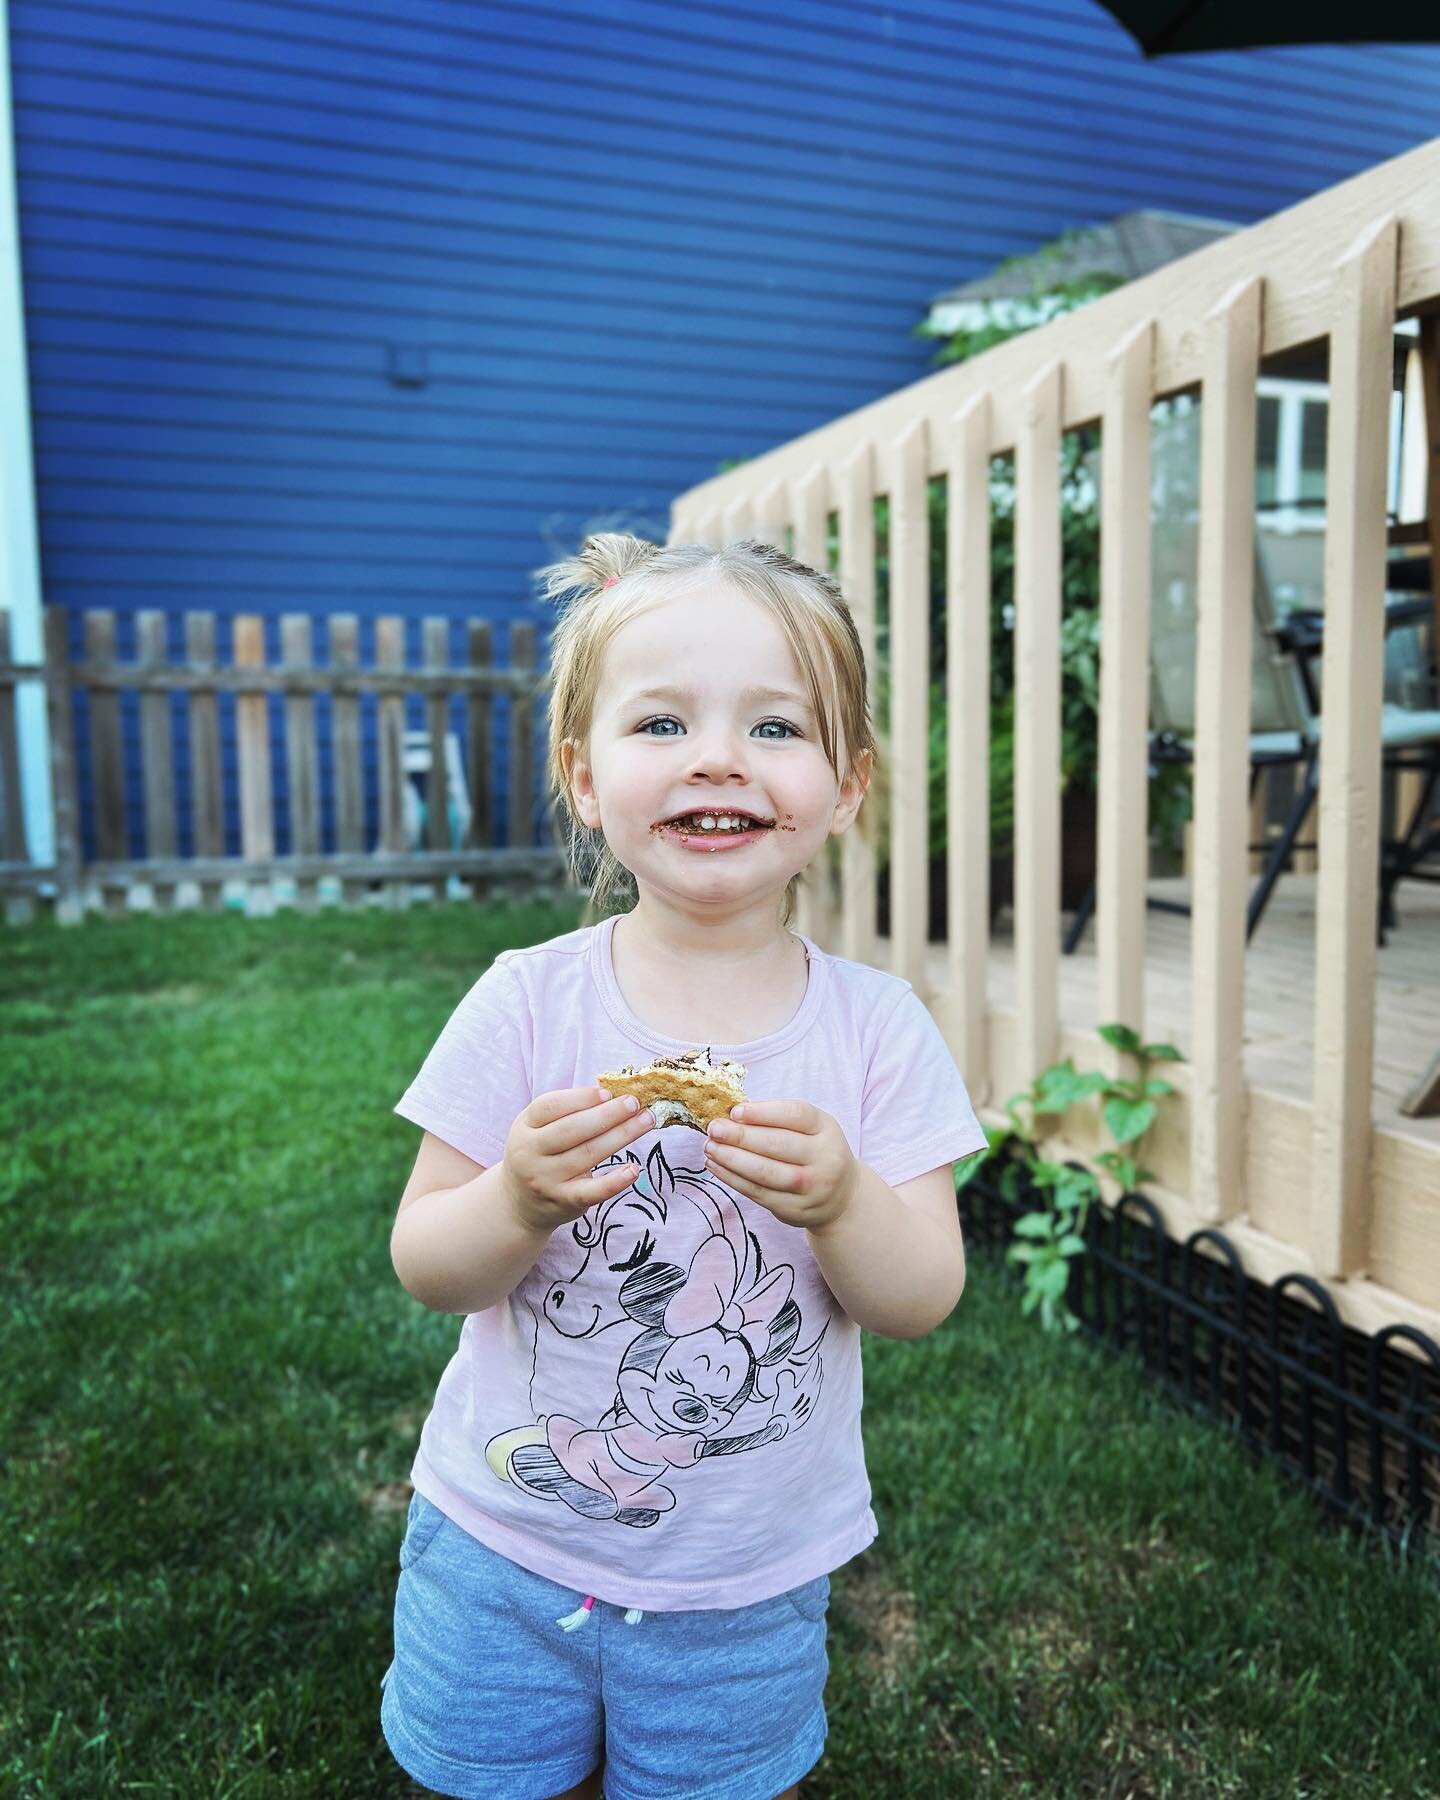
[1310,218,1396,1278]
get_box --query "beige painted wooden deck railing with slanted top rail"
[671,140,1440,1346]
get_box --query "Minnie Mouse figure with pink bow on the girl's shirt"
[486,1183,828,1526]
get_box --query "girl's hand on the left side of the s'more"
[504,1087,655,1231]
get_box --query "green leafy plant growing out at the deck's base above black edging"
[958,1024,1181,1332]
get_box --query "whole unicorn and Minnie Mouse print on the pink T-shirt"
[486,1145,830,1526]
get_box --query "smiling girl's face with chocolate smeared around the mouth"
[572,583,864,904]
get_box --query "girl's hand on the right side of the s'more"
[706,1100,860,1231]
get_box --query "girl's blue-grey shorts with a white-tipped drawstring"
[380,1494,830,1800]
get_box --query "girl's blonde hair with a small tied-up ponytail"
[536,531,880,925]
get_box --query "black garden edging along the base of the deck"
[959,1165,1440,1553]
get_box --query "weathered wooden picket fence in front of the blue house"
[0,607,565,923]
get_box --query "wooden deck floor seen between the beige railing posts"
[964,875,1440,1152]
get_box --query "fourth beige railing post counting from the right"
[1015,362,1064,1082]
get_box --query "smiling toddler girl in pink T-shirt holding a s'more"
[382,535,985,1800]
